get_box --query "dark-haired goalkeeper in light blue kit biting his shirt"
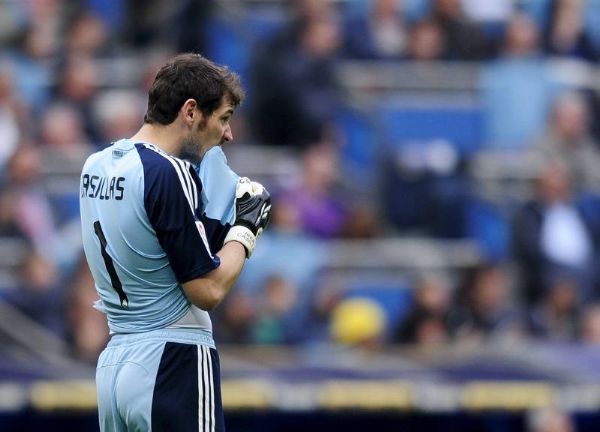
[80,54,271,432]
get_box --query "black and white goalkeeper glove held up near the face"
[224,177,271,258]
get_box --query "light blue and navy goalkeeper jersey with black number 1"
[80,140,237,333]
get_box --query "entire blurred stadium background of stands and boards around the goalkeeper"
[0,0,600,432]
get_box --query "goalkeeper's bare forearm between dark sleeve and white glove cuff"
[183,241,246,310]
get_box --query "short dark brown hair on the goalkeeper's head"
[144,53,244,125]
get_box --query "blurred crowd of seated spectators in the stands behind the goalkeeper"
[0,0,600,368]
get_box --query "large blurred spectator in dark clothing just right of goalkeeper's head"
[250,0,341,148]
